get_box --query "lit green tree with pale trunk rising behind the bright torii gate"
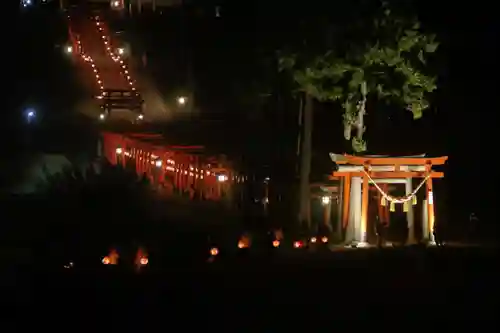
[279,4,438,152]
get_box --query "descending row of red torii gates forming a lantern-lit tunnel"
[98,132,246,200]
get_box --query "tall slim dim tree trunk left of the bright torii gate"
[298,93,313,228]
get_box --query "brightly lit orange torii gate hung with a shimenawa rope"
[330,153,448,246]
